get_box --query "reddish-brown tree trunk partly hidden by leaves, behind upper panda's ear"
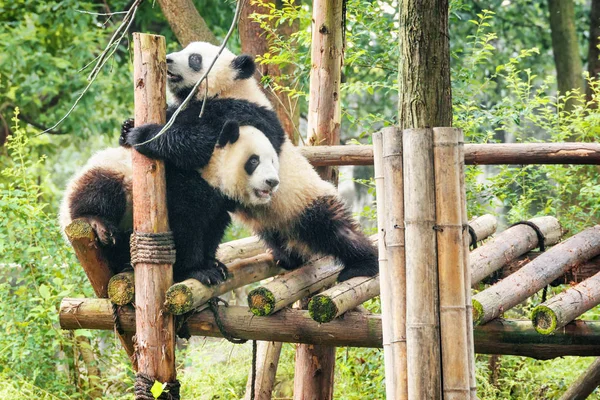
[238,0,300,144]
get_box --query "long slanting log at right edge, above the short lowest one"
[473,225,600,325]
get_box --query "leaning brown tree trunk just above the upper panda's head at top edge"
[158,0,219,47]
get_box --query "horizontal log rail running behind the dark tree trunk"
[300,143,600,166]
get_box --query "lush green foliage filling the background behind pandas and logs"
[0,0,600,399]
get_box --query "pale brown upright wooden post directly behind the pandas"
[294,0,344,400]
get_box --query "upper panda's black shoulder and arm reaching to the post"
[121,99,285,170]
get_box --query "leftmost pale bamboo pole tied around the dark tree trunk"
[373,128,408,400]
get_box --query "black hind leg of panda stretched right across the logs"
[295,196,379,282]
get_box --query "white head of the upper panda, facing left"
[162,42,272,108]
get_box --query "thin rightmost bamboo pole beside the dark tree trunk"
[458,130,478,400]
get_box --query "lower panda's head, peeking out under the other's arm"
[213,121,279,206]
